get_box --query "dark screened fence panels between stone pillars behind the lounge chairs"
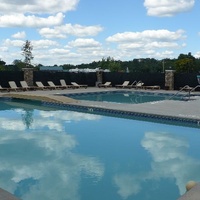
[0,71,198,90]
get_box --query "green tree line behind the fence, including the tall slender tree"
[0,40,200,73]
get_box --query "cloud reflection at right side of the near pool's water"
[114,132,200,199]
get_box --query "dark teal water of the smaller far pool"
[64,91,186,104]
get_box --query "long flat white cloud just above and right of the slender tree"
[39,24,103,38]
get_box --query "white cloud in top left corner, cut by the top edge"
[0,0,79,14]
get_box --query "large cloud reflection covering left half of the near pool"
[0,109,104,200]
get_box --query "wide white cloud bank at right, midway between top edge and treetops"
[106,30,185,57]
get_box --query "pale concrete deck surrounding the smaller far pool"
[0,87,200,124]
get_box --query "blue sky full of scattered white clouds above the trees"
[0,0,200,66]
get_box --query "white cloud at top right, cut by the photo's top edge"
[144,0,195,17]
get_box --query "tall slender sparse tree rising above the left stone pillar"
[22,40,34,67]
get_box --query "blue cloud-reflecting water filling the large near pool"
[0,100,200,200]
